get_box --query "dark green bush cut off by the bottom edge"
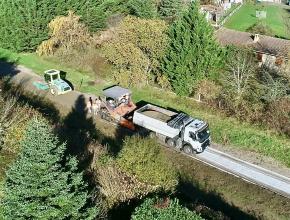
[131,198,202,220]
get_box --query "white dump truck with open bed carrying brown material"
[133,104,210,154]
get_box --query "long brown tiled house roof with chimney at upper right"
[216,27,290,57]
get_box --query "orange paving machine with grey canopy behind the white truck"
[99,86,136,130]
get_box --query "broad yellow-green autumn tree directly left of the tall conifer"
[101,16,167,86]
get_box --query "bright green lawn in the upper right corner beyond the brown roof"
[224,3,290,39]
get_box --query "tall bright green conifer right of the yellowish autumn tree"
[162,2,222,95]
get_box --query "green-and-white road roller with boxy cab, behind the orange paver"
[33,69,72,95]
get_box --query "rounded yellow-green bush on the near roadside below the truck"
[117,137,178,191]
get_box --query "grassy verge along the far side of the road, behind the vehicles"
[0,49,290,167]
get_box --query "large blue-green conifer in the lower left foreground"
[0,119,97,219]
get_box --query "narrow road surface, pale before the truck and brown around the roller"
[0,63,290,198]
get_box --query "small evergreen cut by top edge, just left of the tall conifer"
[159,0,182,17]
